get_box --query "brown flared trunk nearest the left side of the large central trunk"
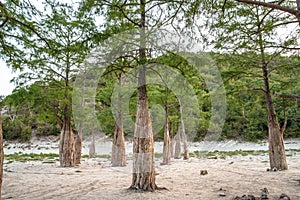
[111,73,126,167]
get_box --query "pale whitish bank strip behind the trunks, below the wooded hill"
[3,138,300,155]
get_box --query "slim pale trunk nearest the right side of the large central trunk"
[162,105,171,165]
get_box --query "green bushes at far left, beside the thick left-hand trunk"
[2,80,60,141]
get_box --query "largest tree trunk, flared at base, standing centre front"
[130,0,157,191]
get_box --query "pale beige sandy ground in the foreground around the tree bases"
[3,152,300,200]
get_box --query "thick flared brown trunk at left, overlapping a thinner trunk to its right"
[59,116,75,167]
